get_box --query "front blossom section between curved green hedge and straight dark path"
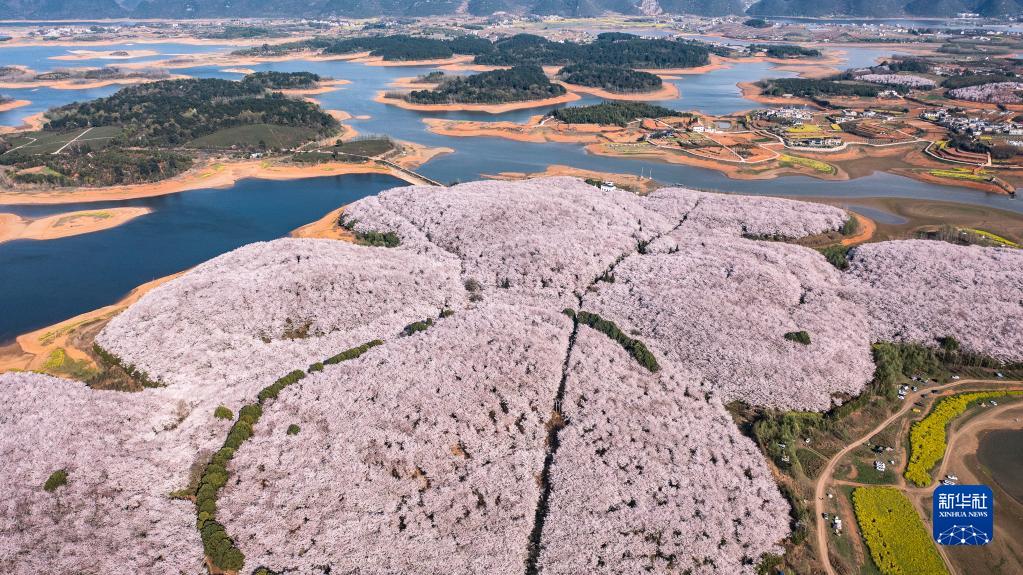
[220,304,571,574]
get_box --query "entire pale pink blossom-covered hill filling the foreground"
[0,178,1023,575]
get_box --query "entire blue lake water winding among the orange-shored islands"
[0,44,1023,342]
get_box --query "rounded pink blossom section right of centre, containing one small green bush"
[584,233,874,410]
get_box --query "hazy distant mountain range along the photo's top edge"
[6,0,1023,19]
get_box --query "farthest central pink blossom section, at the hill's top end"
[346,178,677,292]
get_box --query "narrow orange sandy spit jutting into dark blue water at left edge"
[0,208,152,244]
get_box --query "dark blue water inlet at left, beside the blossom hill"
[0,174,403,342]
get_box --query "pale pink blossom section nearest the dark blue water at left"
[96,239,465,410]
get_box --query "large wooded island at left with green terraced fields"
[0,75,341,186]
